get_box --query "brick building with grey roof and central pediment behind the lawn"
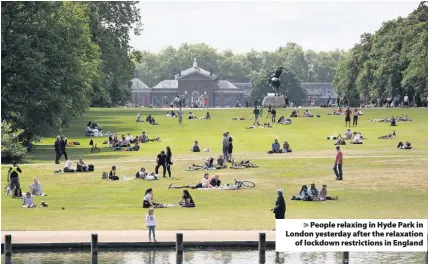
[131,59,244,107]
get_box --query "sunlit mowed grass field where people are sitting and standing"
[1,108,428,230]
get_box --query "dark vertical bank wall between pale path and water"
[1,241,275,254]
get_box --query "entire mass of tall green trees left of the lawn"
[1,1,141,154]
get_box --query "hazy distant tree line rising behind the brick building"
[137,43,345,84]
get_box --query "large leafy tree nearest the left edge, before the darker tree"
[1,2,100,142]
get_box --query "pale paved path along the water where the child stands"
[1,230,275,244]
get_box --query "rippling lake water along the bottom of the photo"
[1,250,424,264]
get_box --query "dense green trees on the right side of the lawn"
[334,1,428,106]
